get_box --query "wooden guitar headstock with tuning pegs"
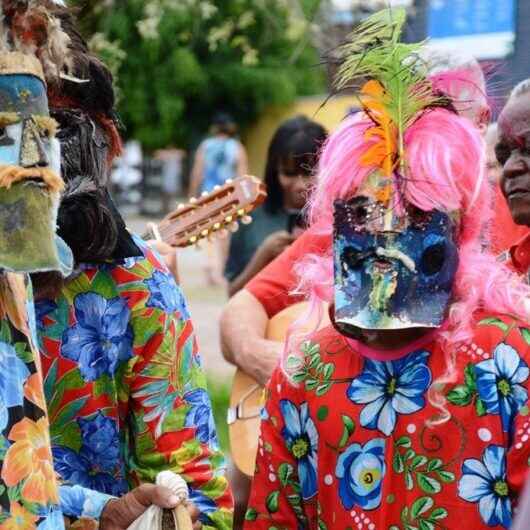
[158,175,267,247]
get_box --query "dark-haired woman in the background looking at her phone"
[225,116,327,296]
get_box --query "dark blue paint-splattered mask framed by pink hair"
[334,173,458,331]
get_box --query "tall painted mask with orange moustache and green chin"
[0,52,72,273]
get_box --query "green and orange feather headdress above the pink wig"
[335,9,447,176]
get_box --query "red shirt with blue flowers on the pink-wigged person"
[245,315,530,530]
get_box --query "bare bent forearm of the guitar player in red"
[221,289,283,384]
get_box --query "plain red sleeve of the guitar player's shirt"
[245,230,327,318]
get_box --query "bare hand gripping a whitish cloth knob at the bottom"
[99,484,201,530]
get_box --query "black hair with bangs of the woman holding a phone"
[265,116,327,213]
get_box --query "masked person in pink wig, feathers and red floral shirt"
[245,10,530,530]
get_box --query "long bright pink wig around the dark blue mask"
[283,108,530,423]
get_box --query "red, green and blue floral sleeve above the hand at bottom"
[125,271,233,529]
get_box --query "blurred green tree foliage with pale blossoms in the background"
[68,0,324,149]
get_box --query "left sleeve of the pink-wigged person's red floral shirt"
[245,369,316,530]
